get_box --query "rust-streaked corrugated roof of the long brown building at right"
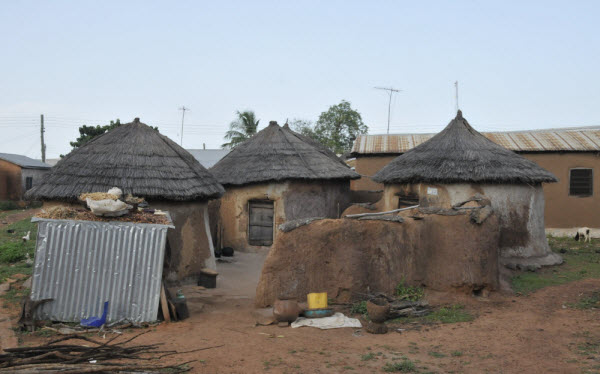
[352,127,600,154]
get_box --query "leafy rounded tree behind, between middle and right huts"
[312,100,369,154]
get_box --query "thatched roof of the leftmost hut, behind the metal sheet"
[26,118,224,201]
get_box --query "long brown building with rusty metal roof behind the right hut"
[351,127,600,229]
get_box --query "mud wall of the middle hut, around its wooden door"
[216,181,350,252]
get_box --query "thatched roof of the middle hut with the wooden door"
[210,121,360,185]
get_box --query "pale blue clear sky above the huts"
[0,0,600,158]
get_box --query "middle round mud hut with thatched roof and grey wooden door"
[210,121,360,252]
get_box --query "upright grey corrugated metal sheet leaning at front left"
[31,218,173,322]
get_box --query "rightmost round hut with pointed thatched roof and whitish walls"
[373,111,562,267]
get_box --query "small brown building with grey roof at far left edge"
[0,153,52,201]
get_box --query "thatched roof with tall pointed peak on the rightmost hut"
[373,110,557,184]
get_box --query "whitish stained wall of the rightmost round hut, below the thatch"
[381,183,562,266]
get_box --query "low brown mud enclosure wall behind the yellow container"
[256,214,499,307]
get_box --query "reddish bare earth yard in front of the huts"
[0,209,600,373]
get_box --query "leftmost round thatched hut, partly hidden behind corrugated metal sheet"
[27,118,224,281]
